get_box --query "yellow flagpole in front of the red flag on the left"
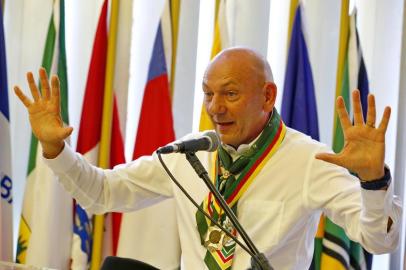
[90,0,119,270]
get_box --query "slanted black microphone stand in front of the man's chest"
[185,152,273,270]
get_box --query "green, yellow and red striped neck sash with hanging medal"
[196,110,286,270]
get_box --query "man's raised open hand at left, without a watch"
[14,68,73,158]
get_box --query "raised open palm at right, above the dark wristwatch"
[316,90,391,181]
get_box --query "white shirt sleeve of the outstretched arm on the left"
[44,144,172,214]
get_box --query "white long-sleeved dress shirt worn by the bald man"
[46,128,402,270]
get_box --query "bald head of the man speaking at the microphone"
[203,48,277,147]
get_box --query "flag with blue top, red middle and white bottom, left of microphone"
[118,17,180,269]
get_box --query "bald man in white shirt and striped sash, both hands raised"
[15,48,402,269]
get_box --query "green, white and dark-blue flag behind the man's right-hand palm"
[320,9,372,270]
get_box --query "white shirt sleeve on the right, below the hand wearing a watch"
[304,146,402,254]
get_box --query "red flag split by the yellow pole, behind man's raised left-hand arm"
[72,0,125,268]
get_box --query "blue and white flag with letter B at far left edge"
[0,2,13,261]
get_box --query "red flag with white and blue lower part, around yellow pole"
[71,1,127,269]
